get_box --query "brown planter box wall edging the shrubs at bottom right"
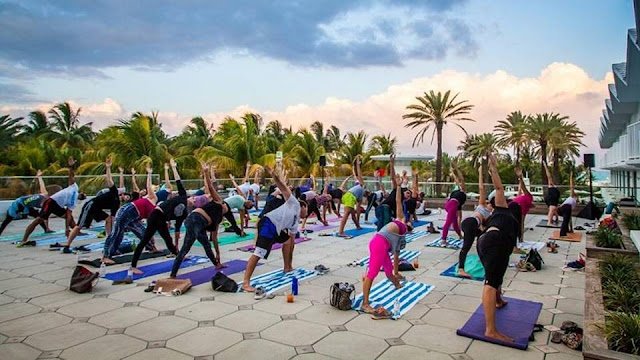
[582,257,640,360]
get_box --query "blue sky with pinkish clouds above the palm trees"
[0,0,635,160]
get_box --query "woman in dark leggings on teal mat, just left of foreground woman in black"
[458,165,491,279]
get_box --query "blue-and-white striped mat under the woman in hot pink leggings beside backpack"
[352,280,434,318]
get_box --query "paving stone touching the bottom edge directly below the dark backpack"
[313,331,389,359]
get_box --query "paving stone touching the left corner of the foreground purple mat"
[401,324,471,354]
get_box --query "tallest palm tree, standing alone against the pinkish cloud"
[402,90,474,188]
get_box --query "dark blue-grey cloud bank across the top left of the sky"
[0,0,477,76]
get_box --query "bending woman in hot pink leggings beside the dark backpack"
[361,173,411,318]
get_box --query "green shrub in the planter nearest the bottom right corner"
[604,312,640,355]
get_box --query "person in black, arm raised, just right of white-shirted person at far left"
[63,158,124,254]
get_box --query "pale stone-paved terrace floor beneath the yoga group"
[0,211,584,360]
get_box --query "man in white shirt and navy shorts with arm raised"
[242,167,307,292]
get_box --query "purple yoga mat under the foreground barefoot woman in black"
[456,298,542,350]
